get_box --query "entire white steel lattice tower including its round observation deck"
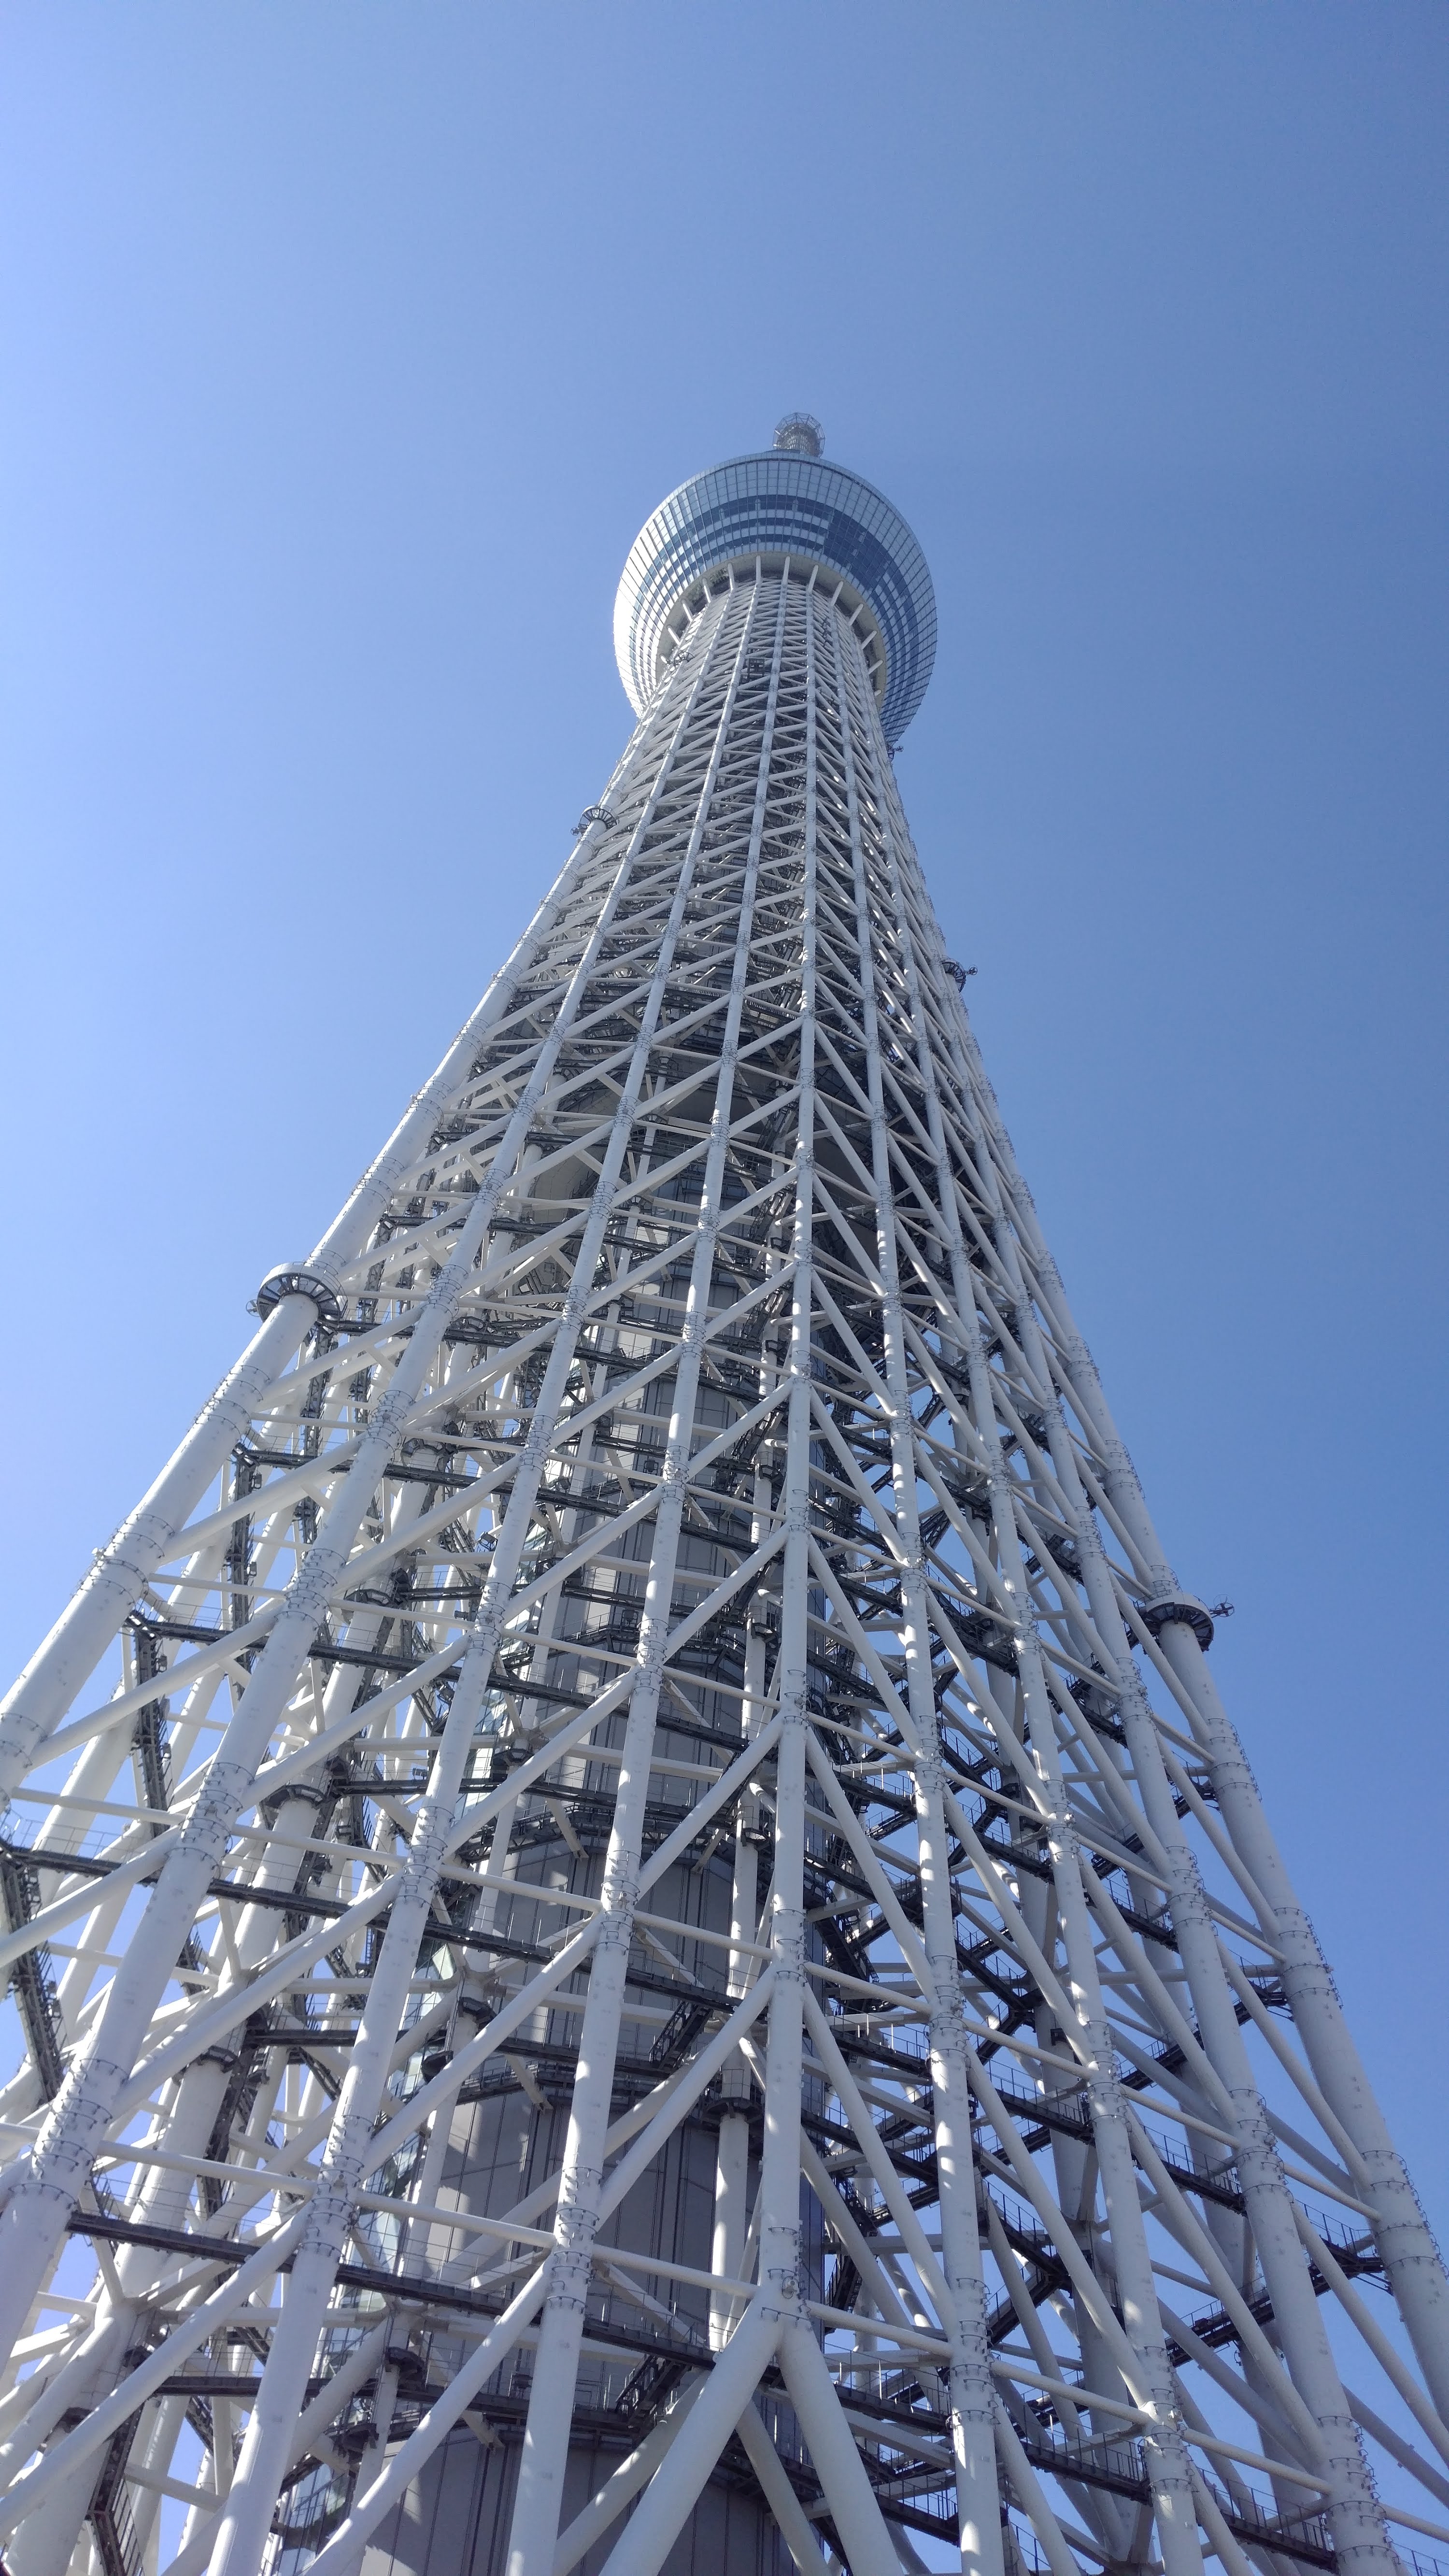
[0,420,1449,2576]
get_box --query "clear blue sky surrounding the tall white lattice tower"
[0,0,1449,2256]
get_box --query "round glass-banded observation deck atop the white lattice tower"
[615,415,937,747]
